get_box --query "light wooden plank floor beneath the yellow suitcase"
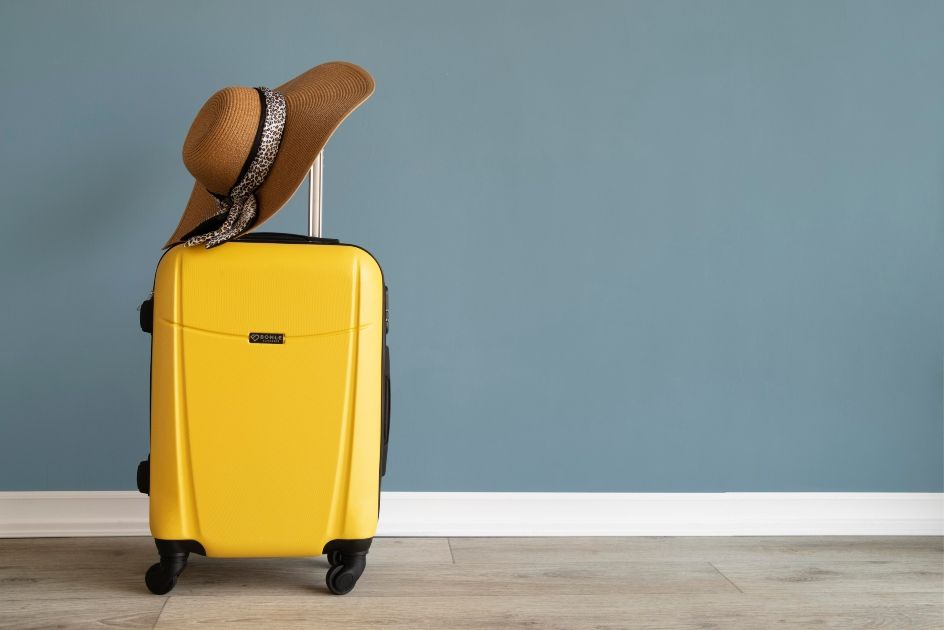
[0,537,944,630]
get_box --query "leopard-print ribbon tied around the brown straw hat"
[186,88,285,249]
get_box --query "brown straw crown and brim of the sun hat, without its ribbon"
[164,61,374,248]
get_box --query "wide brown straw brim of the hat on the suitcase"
[164,61,374,248]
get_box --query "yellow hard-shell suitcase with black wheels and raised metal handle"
[138,155,390,594]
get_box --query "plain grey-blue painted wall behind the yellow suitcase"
[0,0,944,491]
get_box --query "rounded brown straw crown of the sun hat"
[183,87,262,195]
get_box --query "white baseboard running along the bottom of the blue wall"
[0,492,944,538]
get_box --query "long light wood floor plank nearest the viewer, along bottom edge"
[149,594,941,630]
